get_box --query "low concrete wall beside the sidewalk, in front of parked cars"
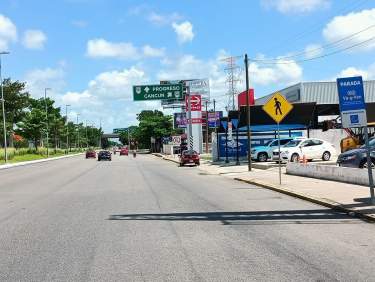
[286,163,369,186]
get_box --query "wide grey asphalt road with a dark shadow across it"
[0,155,375,281]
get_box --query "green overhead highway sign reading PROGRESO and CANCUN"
[133,84,183,101]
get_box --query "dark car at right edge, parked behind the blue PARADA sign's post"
[337,139,375,168]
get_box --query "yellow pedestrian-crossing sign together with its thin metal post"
[263,92,293,185]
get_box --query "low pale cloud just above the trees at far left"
[25,66,65,98]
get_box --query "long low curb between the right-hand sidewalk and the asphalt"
[234,177,375,222]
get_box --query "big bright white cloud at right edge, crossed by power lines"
[323,8,375,50]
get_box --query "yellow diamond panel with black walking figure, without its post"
[263,92,293,123]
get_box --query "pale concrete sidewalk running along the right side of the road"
[155,156,375,222]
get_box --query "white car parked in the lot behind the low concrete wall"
[272,138,336,162]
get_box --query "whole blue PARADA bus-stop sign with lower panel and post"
[337,76,375,205]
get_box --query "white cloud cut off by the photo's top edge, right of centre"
[261,0,330,14]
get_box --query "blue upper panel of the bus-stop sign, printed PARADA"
[337,76,366,112]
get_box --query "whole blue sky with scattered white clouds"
[0,0,375,131]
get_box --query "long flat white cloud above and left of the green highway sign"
[86,38,165,60]
